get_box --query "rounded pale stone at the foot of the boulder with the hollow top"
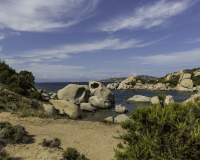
[89,96,112,108]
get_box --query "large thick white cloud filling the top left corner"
[0,0,98,32]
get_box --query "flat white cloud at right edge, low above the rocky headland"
[131,48,200,65]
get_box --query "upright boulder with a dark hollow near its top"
[89,81,115,103]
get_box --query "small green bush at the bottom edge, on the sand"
[61,148,89,160]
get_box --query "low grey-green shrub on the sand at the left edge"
[0,122,29,143]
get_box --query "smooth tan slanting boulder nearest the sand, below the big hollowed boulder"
[50,100,82,119]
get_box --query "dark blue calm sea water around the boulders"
[35,82,195,121]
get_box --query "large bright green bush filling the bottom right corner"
[115,99,200,160]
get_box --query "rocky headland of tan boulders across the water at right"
[107,69,200,92]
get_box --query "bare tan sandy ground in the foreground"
[0,112,125,160]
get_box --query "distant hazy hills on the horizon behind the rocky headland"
[99,75,158,82]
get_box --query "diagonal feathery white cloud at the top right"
[100,0,194,31]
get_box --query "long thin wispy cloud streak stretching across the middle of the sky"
[20,37,168,60]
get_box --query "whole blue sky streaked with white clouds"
[0,0,200,82]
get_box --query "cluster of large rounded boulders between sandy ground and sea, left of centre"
[38,81,115,119]
